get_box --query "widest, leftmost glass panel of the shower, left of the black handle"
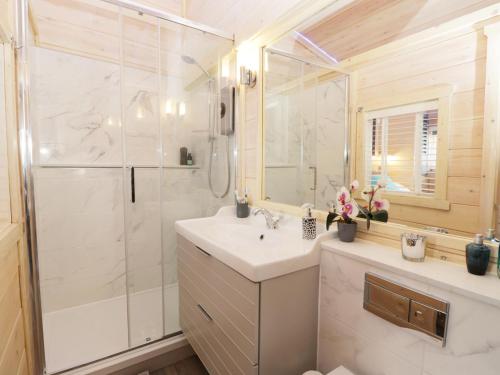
[28,0,129,373]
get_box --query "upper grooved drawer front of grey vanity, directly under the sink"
[177,236,259,365]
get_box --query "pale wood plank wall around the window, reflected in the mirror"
[357,28,486,235]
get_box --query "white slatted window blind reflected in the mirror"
[365,100,438,195]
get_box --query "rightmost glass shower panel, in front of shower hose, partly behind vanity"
[160,16,235,335]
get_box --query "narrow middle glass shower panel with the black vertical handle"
[121,9,164,347]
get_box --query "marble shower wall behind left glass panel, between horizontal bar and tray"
[34,168,125,312]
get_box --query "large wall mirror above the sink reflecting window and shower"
[262,0,500,237]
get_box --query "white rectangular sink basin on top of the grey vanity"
[175,206,332,282]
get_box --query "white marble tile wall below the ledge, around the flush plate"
[318,251,500,375]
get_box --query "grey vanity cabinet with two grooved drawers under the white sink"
[177,236,319,375]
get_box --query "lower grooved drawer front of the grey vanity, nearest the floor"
[179,286,258,375]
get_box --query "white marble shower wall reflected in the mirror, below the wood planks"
[265,73,346,210]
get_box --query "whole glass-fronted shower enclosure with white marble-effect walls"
[19,0,235,374]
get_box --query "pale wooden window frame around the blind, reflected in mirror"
[355,85,453,210]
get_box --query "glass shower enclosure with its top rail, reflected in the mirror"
[264,48,349,209]
